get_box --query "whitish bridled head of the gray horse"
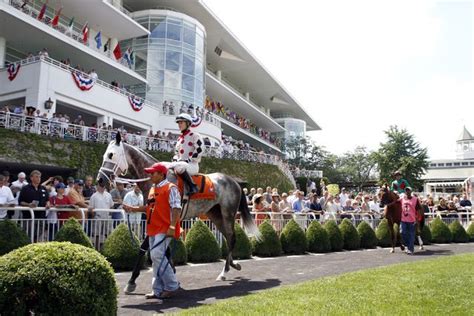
[97,132,128,188]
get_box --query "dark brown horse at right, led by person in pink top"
[380,185,425,253]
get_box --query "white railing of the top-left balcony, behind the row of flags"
[10,0,129,68]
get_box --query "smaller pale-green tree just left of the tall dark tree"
[341,147,377,191]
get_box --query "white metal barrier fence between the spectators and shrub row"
[2,207,474,250]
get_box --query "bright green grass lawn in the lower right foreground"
[179,254,474,315]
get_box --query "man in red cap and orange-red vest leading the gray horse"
[123,163,181,299]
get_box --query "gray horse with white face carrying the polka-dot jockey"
[97,133,260,292]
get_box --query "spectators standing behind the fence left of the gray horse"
[0,170,143,240]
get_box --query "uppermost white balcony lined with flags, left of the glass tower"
[0,0,148,84]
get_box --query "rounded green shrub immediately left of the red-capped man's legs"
[102,224,145,271]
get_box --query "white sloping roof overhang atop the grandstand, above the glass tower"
[124,0,321,131]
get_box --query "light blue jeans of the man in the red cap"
[150,234,179,296]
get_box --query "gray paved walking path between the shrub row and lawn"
[116,243,474,315]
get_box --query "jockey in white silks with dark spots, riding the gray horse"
[170,113,203,195]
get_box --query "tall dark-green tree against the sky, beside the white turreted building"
[374,126,429,188]
